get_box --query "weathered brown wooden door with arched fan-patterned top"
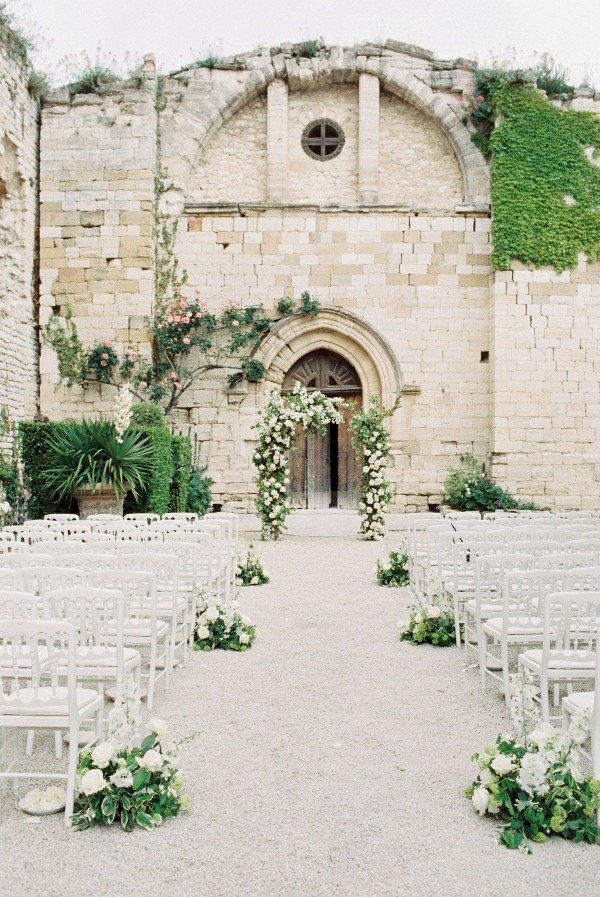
[282,349,362,508]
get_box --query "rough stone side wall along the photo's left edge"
[0,47,39,447]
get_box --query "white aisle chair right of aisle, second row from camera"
[519,591,600,722]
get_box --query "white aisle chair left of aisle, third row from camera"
[87,569,171,710]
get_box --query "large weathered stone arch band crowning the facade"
[161,47,489,208]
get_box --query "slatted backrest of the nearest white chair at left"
[0,619,77,708]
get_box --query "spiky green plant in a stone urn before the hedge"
[44,420,153,519]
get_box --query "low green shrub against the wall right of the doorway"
[444,455,535,511]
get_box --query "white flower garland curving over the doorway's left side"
[252,384,344,539]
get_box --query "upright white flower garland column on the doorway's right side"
[350,395,400,541]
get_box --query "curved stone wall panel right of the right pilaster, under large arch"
[379,93,463,209]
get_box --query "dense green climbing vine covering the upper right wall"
[468,69,600,271]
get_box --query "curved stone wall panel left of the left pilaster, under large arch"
[191,96,267,202]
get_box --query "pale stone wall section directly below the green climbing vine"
[492,257,600,510]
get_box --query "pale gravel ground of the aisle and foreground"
[0,536,600,897]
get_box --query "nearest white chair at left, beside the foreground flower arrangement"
[0,620,103,824]
